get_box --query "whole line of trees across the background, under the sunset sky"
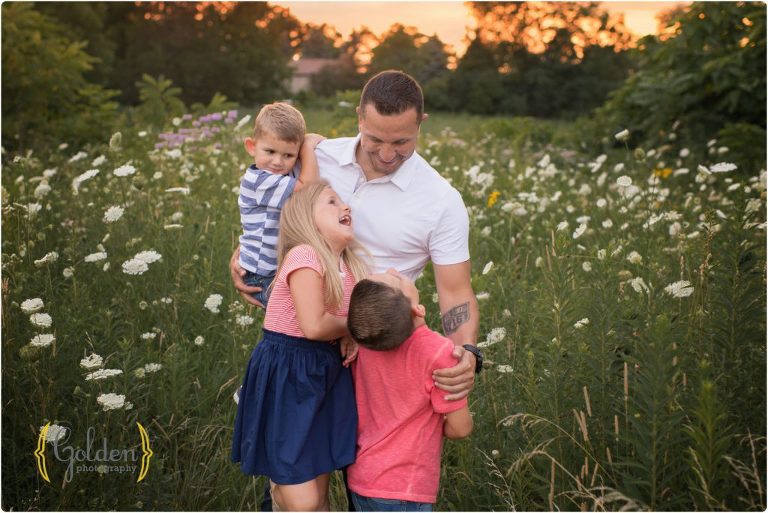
[2,2,766,166]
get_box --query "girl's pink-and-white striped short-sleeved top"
[264,244,355,338]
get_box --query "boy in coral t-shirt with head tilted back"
[347,269,472,511]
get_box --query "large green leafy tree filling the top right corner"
[599,2,766,171]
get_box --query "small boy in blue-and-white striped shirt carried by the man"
[237,102,325,308]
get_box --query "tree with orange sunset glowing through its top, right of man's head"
[449,2,630,117]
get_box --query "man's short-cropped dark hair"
[360,70,424,123]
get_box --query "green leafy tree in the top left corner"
[2,3,117,148]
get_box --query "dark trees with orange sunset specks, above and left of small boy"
[115,2,300,103]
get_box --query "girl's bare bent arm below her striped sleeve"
[288,267,347,340]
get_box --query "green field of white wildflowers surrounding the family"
[2,104,766,511]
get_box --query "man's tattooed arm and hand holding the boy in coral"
[433,260,480,400]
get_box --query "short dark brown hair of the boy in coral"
[347,280,413,351]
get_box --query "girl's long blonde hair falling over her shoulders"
[273,180,371,308]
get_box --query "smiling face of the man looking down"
[357,104,426,179]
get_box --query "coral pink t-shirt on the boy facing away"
[350,326,467,503]
